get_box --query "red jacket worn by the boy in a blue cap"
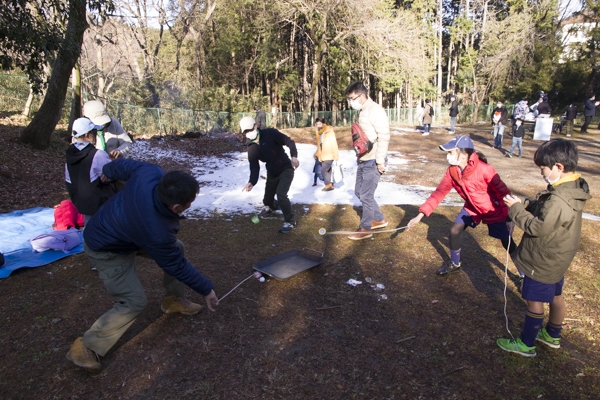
[419,153,510,224]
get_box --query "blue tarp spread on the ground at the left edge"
[0,207,83,278]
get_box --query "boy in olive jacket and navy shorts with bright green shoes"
[497,139,591,357]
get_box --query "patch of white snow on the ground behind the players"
[130,140,600,221]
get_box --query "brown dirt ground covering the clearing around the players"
[0,117,600,399]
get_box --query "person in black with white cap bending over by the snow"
[240,116,300,233]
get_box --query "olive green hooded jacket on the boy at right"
[509,173,592,284]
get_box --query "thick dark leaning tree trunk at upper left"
[21,0,88,149]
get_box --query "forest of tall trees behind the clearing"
[0,0,600,147]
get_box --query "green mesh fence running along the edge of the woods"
[0,74,568,136]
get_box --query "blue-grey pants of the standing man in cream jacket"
[354,160,385,229]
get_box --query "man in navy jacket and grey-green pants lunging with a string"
[67,159,218,371]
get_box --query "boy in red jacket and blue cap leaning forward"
[406,136,516,275]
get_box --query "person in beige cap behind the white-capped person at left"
[83,100,132,160]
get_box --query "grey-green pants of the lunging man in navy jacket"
[83,240,185,356]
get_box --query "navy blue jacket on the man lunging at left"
[84,158,213,296]
